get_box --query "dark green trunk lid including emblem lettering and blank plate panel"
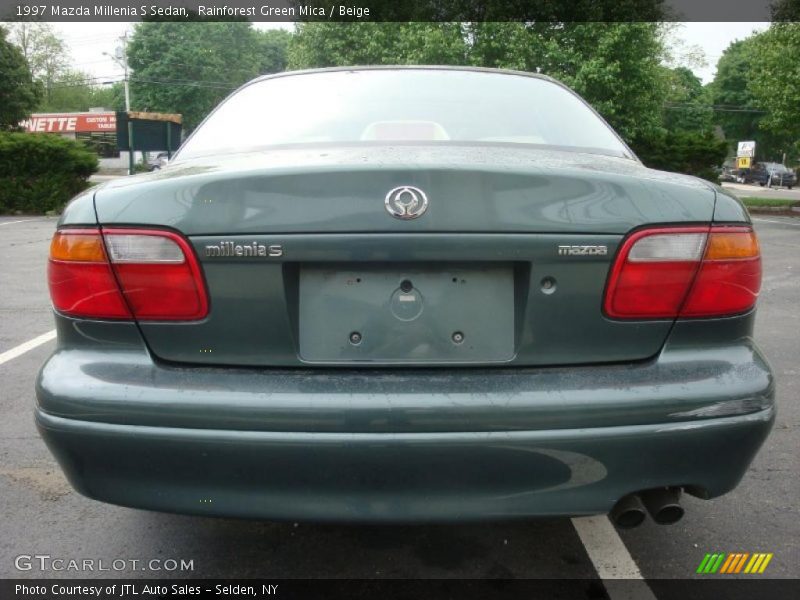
[95,145,714,366]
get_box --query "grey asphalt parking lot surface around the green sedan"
[0,217,800,598]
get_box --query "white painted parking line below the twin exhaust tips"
[572,515,655,600]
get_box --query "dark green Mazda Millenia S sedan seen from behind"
[36,67,775,526]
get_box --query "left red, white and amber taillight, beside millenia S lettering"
[48,229,208,321]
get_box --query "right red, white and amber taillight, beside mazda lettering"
[604,226,761,319]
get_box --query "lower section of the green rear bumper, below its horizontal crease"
[36,408,774,521]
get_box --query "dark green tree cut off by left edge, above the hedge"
[0,27,40,130]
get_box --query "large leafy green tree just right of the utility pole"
[128,21,282,130]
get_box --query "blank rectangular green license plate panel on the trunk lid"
[298,263,515,364]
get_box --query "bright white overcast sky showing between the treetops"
[42,22,769,88]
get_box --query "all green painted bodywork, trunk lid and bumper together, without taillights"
[36,68,775,521]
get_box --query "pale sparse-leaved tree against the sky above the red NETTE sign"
[6,21,69,100]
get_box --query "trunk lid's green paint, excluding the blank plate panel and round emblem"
[81,146,715,366]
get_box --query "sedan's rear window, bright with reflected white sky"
[178,69,629,158]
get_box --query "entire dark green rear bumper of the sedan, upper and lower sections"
[36,318,775,521]
